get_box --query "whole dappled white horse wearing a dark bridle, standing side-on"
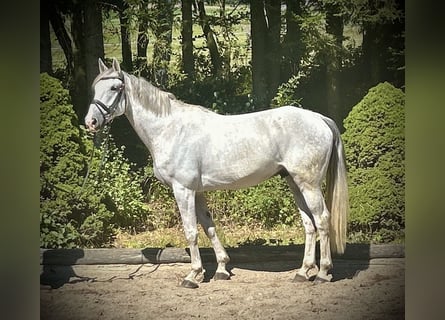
[85,59,349,288]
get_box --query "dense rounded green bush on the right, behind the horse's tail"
[343,82,405,241]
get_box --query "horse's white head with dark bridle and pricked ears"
[85,58,126,131]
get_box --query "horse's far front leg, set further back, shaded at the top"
[196,193,230,280]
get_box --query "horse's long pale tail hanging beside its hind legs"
[323,117,349,254]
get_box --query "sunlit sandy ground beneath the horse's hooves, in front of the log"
[40,258,405,320]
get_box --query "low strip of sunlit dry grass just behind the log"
[112,225,304,248]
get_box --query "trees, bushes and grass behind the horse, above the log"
[40,0,405,247]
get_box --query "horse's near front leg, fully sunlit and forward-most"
[173,184,205,288]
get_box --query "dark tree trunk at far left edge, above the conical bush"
[40,1,53,74]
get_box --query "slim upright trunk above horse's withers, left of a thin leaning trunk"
[181,0,195,79]
